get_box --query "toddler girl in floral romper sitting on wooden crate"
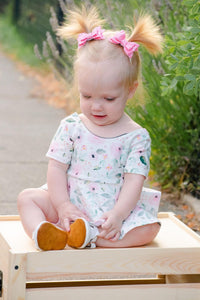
[18,8,162,250]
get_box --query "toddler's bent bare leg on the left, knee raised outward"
[17,188,58,237]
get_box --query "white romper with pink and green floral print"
[47,113,160,238]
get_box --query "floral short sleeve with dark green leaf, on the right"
[124,129,151,177]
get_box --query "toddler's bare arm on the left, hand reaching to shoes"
[47,159,88,231]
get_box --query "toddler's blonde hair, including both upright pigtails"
[58,6,163,87]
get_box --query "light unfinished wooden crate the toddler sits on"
[0,213,200,300]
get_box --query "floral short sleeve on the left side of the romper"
[46,117,75,164]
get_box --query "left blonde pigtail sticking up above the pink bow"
[57,6,104,39]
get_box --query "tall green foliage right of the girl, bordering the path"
[128,0,200,198]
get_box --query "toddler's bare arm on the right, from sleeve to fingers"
[99,173,145,240]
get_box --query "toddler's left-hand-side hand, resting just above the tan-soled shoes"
[58,202,89,232]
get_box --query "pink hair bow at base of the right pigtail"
[109,30,139,58]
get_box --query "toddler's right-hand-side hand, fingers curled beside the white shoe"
[99,210,123,241]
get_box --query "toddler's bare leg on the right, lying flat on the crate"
[96,223,160,248]
